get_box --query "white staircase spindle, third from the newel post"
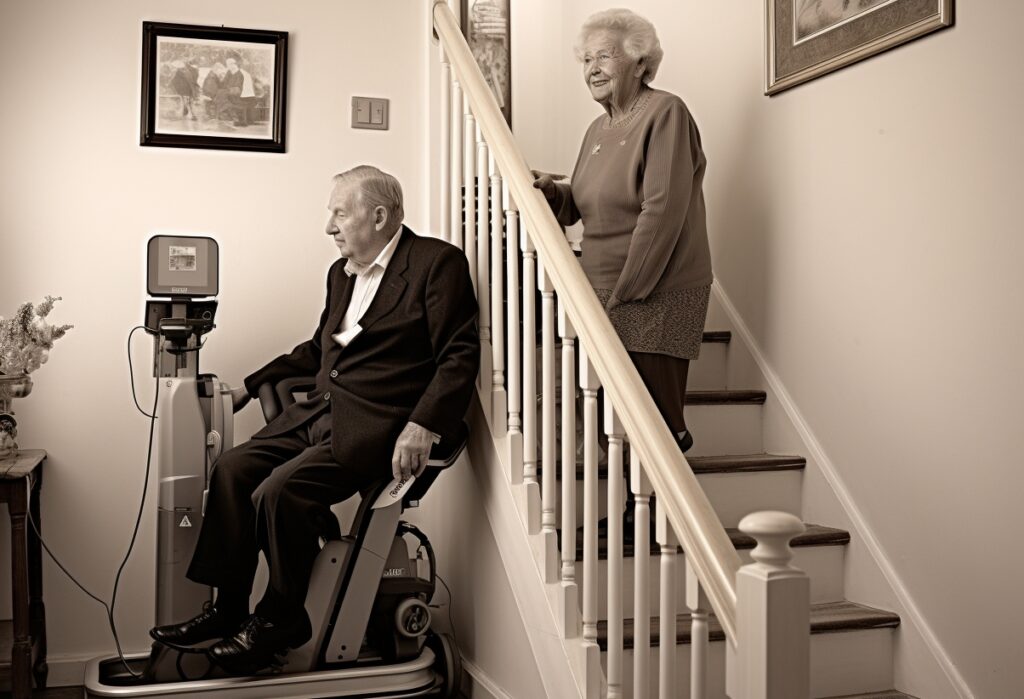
[630,449,651,699]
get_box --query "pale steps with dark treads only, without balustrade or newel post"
[552,331,908,699]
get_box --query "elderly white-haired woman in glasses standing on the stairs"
[534,9,712,451]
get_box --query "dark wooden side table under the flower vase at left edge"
[0,449,47,699]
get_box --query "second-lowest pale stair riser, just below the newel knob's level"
[577,547,844,619]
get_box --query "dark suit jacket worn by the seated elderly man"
[245,226,480,476]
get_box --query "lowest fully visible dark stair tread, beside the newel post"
[597,601,899,651]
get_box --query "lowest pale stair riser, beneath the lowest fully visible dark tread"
[601,628,893,699]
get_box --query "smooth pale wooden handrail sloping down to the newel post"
[431,0,740,644]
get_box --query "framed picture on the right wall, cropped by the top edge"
[765,0,953,94]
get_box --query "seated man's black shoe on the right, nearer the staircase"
[207,613,312,674]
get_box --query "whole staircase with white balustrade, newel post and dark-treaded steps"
[432,0,921,699]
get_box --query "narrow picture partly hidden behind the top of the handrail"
[460,0,512,128]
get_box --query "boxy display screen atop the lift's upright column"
[146,235,219,298]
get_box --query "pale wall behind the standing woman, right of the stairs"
[513,0,1024,699]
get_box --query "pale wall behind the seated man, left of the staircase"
[0,0,429,665]
